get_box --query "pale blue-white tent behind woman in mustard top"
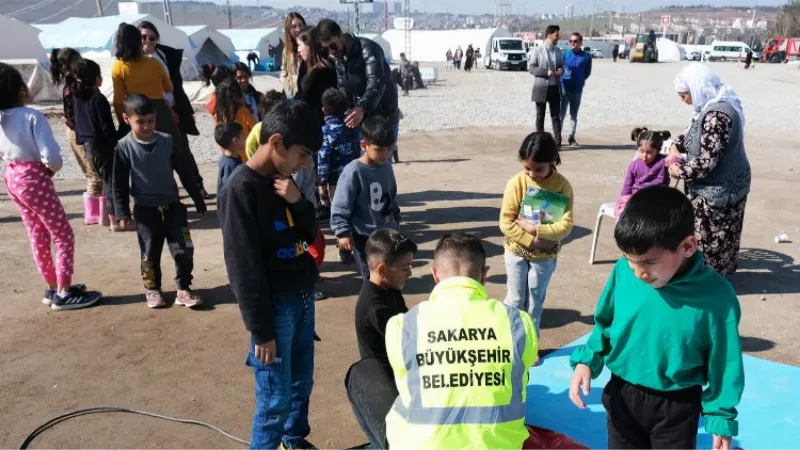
[35,14,194,60]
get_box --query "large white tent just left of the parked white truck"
[381,28,511,62]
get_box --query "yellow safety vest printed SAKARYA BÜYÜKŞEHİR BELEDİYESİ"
[386,277,538,450]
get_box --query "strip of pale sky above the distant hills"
[222,0,786,14]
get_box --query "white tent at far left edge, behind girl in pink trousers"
[0,16,61,102]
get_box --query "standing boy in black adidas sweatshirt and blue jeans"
[218,100,322,450]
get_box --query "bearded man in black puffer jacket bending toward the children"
[317,19,400,162]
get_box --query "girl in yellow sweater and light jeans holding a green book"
[500,132,573,336]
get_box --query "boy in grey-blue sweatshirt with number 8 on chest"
[331,116,400,282]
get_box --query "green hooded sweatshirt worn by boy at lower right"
[570,251,744,436]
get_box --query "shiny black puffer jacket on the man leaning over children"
[332,33,400,123]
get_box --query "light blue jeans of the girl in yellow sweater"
[503,250,557,337]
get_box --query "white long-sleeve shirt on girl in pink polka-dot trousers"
[0,106,64,172]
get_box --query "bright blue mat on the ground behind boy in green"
[525,335,800,450]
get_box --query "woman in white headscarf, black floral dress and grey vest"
[667,63,751,275]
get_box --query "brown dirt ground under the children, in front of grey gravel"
[0,125,800,450]
